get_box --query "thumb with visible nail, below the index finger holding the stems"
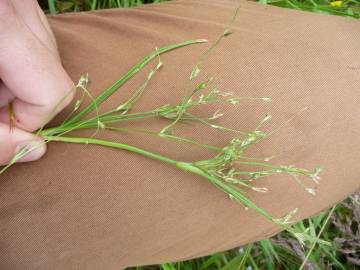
[0,123,46,165]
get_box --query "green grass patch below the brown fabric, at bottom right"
[132,192,360,270]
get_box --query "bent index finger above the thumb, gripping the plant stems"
[0,1,73,131]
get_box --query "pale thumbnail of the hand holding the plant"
[15,140,46,162]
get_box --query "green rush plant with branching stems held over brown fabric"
[0,4,321,245]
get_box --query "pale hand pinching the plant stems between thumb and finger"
[0,0,74,165]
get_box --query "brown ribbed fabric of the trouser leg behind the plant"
[0,0,360,270]
